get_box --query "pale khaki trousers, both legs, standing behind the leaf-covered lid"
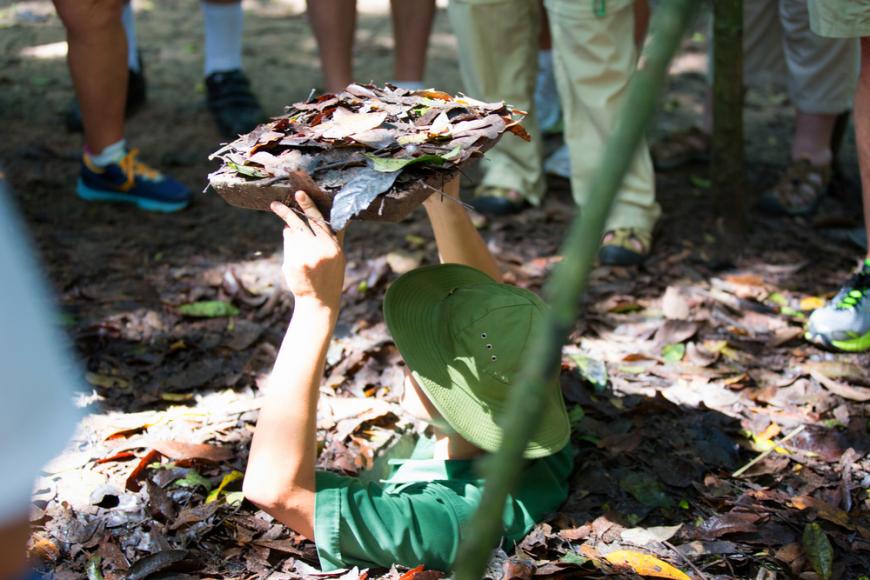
[449,0,661,231]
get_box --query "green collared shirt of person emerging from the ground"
[314,440,574,571]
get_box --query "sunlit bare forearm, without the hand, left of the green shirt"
[245,301,338,538]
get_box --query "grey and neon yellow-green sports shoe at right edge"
[806,259,870,352]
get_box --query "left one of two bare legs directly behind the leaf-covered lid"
[308,0,356,92]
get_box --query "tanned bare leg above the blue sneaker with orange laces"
[54,0,125,153]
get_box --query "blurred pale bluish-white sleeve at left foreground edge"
[0,180,81,526]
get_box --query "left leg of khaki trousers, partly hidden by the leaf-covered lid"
[448,0,545,204]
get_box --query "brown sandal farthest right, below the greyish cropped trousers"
[759,159,831,216]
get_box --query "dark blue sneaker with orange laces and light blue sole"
[76,149,190,213]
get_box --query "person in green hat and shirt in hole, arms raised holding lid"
[243,179,573,570]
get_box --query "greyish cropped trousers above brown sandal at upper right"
[743,0,859,115]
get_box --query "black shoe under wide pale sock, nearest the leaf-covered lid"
[205,69,266,139]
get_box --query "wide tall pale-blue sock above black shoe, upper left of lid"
[200,2,245,76]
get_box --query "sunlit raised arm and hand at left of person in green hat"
[244,192,345,540]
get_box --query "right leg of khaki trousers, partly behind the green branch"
[544,0,661,231]
